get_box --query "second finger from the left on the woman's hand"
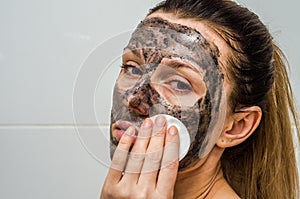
[122,118,153,182]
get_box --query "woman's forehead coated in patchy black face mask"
[125,17,219,73]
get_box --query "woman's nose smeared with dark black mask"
[129,84,153,116]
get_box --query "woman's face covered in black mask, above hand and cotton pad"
[111,18,226,170]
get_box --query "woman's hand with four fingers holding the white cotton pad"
[100,116,179,199]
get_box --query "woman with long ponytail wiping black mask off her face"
[100,0,299,199]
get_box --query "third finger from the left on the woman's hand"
[139,116,166,185]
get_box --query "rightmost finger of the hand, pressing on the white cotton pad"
[156,126,179,193]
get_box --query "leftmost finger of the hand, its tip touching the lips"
[106,126,135,182]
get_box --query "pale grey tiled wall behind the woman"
[0,0,300,199]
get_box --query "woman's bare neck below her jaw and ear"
[174,146,223,199]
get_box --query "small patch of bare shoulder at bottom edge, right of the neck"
[208,179,241,199]
